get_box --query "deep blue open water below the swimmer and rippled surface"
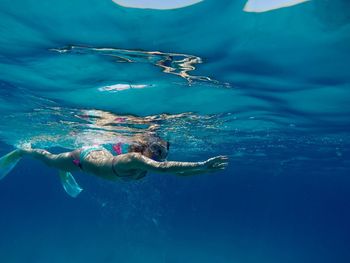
[0,139,350,263]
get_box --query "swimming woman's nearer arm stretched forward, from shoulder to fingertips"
[124,153,228,176]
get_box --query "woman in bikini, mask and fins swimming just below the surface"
[0,136,228,197]
